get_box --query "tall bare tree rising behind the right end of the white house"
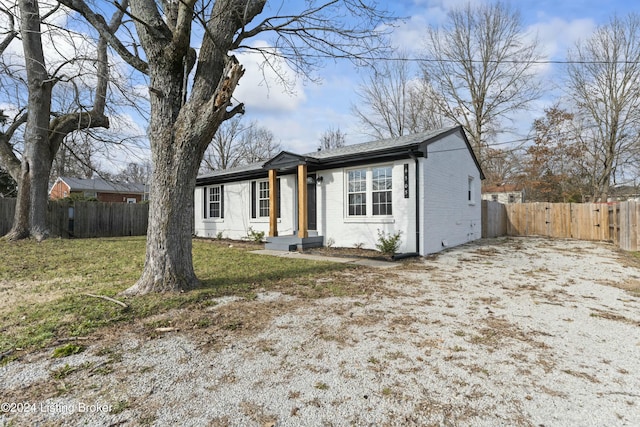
[422,2,541,173]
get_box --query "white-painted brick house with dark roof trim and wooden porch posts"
[195,127,484,255]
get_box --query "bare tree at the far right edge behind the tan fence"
[567,14,640,201]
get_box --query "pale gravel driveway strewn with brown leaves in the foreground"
[0,238,640,427]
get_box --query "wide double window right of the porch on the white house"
[347,166,393,217]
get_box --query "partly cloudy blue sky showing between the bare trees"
[0,0,640,176]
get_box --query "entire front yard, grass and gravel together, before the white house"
[0,238,640,427]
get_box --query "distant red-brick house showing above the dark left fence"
[49,176,149,203]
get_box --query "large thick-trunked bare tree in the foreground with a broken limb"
[60,0,396,294]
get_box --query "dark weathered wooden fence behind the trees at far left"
[0,199,149,238]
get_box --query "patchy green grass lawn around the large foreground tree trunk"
[0,237,366,361]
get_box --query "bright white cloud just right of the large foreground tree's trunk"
[234,41,306,112]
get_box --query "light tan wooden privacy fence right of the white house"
[482,200,640,251]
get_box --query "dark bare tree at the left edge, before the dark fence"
[0,0,126,240]
